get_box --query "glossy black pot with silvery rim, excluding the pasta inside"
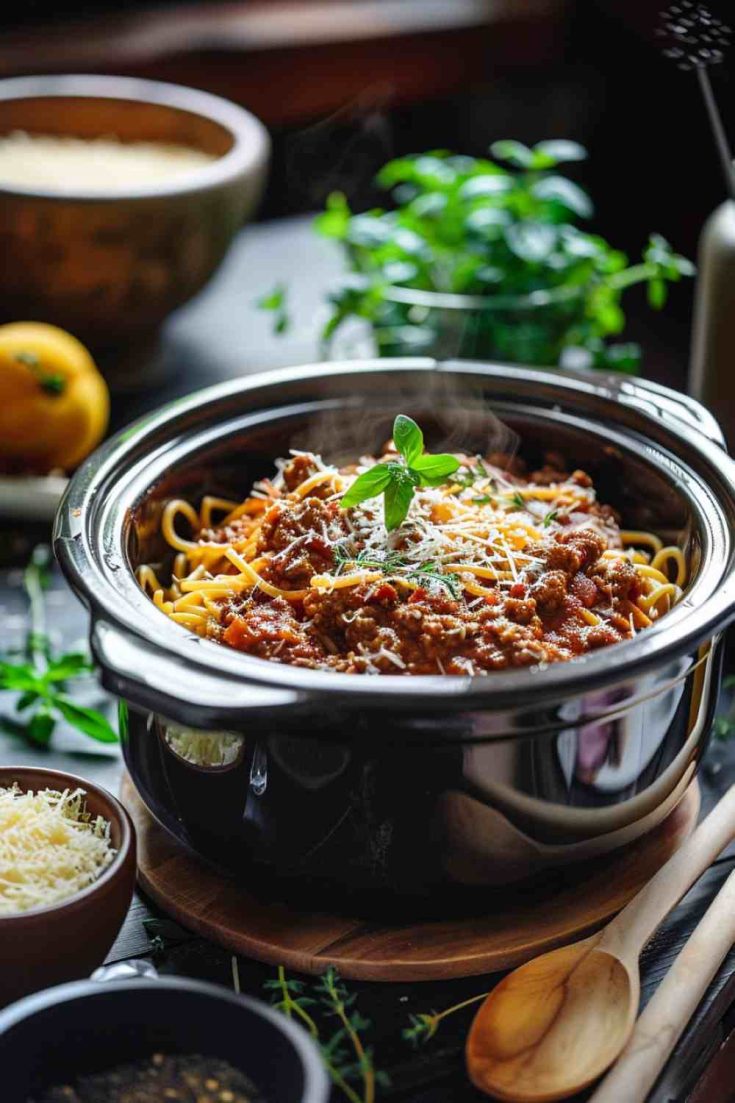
[55,361,735,910]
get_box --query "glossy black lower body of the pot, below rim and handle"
[124,647,718,907]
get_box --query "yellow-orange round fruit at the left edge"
[0,322,109,471]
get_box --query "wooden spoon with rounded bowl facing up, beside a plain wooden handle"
[467,785,735,1103]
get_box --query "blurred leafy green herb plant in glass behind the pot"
[260,139,694,373]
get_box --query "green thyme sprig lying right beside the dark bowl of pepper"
[264,965,390,1103]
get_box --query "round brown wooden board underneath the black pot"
[121,777,700,981]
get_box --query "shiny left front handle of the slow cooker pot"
[90,619,301,728]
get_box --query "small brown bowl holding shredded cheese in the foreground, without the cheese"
[0,767,136,1006]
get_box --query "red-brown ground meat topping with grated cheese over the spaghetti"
[174,443,662,675]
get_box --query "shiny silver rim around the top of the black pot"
[55,360,735,707]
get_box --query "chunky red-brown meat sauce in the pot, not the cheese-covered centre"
[212,456,641,675]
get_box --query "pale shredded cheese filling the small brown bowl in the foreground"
[0,784,116,917]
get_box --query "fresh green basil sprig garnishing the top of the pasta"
[340,414,459,533]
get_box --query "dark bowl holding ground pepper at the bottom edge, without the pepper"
[0,977,329,1103]
